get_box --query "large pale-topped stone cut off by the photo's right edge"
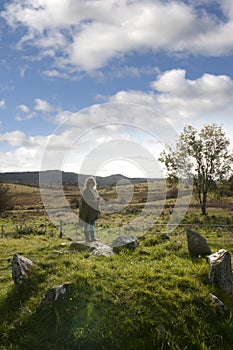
[207,249,233,295]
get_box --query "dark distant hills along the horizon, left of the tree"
[0,170,155,186]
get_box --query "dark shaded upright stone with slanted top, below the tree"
[186,229,211,257]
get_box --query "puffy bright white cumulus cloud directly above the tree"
[106,69,233,125]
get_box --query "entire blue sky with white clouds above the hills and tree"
[0,0,233,177]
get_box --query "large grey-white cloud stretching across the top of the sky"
[2,0,233,75]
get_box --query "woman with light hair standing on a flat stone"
[79,177,100,242]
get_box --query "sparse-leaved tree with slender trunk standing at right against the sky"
[159,124,233,215]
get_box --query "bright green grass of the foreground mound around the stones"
[0,231,233,350]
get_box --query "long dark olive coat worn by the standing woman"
[79,187,99,225]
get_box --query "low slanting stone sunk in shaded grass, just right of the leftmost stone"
[37,282,71,310]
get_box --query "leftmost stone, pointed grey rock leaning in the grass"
[12,254,33,287]
